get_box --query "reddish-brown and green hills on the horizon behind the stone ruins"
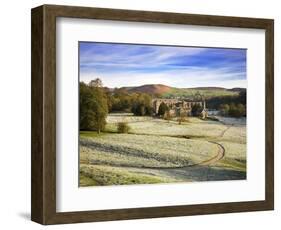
[115,84,246,99]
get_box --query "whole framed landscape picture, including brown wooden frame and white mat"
[31,5,274,225]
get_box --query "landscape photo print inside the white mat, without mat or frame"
[78,41,247,187]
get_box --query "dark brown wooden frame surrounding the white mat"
[31,5,274,224]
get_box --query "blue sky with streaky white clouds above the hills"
[79,42,247,88]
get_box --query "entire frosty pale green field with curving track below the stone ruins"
[80,114,246,186]
